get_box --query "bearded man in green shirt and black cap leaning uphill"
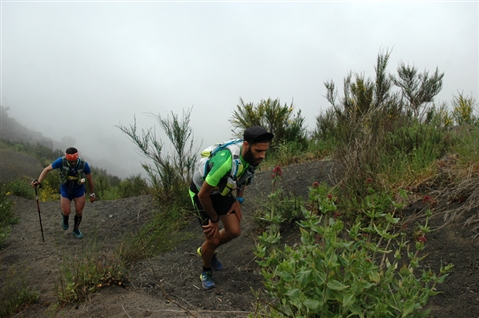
[190,126,273,289]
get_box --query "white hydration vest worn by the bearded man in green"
[193,139,255,196]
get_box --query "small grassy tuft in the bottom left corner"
[0,266,40,317]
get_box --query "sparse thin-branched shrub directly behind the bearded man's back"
[117,109,198,206]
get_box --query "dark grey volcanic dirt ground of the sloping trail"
[0,162,479,318]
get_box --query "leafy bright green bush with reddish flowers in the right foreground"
[255,185,452,317]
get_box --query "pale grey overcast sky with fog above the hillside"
[1,1,479,177]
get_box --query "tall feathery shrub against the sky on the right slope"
[313,52,443,144]
